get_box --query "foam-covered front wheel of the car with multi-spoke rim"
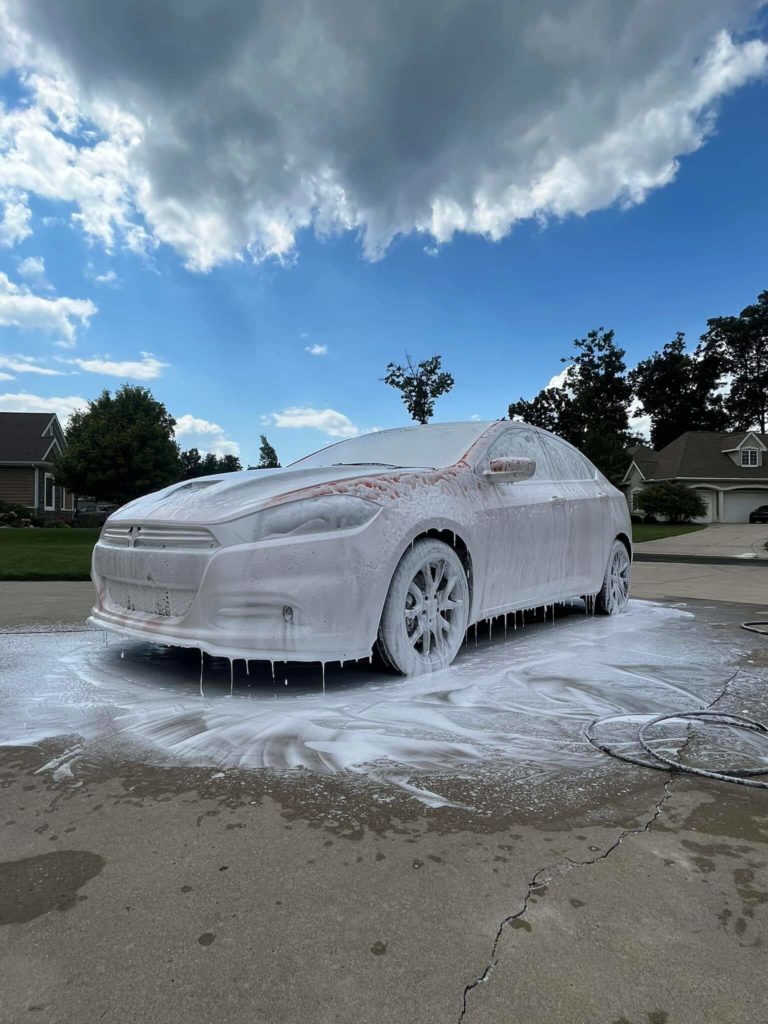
[378,538,469,676]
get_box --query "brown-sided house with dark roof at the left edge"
[0,413,74,519]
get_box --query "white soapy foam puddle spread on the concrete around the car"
[0,601,757,805]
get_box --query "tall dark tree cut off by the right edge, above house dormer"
[701,292,768,433]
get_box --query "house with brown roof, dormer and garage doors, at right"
[620,430,768,522]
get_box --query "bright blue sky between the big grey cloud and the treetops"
[0,1,768,464]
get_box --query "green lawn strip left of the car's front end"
[0,527,99,580]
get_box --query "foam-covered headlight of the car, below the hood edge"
[254,495,381,541]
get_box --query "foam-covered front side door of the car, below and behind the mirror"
[477,425,562,616]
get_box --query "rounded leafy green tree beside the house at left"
[54,384,180,505]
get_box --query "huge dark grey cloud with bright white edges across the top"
[0,0,768,270]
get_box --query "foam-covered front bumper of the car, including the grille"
[89,522,393,662]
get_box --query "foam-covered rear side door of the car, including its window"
[539,433,607,598]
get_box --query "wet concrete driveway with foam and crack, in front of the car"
[0,602,768,1024]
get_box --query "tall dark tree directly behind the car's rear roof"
[509,328,635,478]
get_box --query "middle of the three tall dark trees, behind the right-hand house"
[629,331,728,450]
